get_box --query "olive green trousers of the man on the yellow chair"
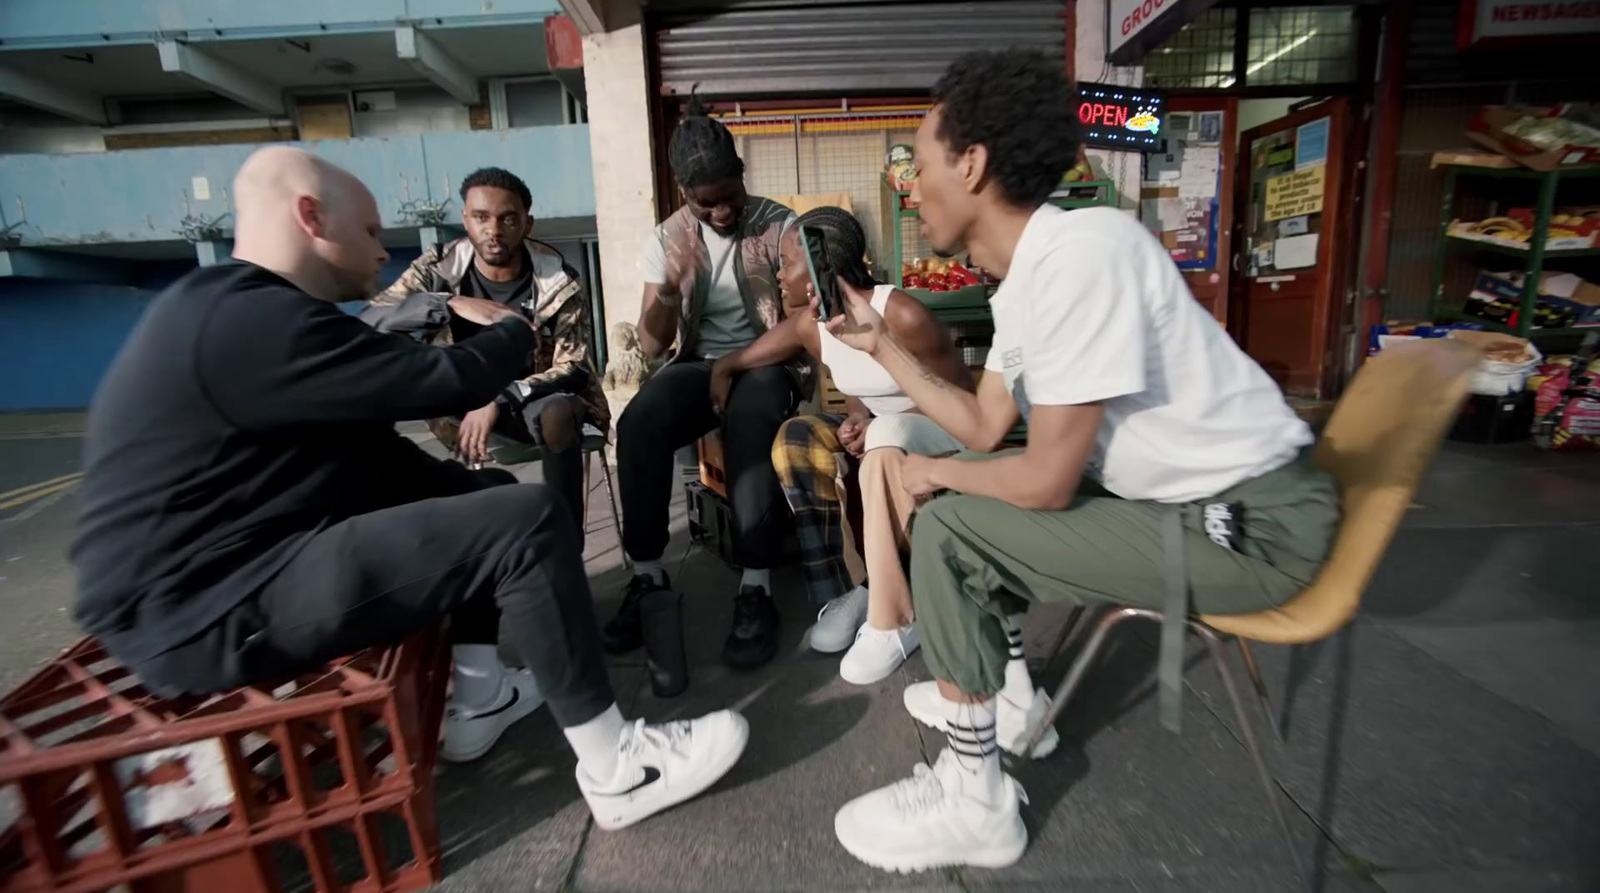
[910,453,1339,695]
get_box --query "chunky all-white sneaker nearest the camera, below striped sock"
[834,749,1027,872]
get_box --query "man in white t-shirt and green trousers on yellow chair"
[830,51,1338,871]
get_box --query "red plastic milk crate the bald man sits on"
[0,629,450,893]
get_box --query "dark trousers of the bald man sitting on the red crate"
[133,463,616,728]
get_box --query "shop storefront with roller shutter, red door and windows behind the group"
[608,0,1595,398]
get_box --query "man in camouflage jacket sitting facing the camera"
[362,168,611,523]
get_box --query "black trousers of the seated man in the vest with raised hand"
[616,360,800,568]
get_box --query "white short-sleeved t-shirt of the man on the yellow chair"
[986,205,1312,503]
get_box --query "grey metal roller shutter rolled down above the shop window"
[654,0,1067,98]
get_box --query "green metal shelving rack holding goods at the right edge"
[1429,165,1600,338]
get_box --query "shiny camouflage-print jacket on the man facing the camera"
[362,238,611,432]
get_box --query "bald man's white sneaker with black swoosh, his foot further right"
[578,711,750,831]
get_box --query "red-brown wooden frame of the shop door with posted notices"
[1229,96,1360,397]
